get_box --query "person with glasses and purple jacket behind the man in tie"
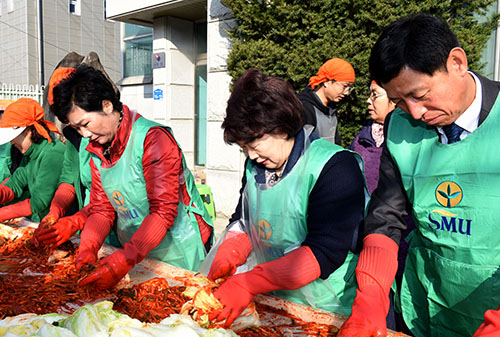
[349,81,396,194]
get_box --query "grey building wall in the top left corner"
[0,0,121,84]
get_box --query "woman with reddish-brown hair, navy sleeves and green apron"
[204,69,365,326]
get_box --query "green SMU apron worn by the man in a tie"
[387,99,500,337]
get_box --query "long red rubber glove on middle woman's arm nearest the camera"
[209,246,321,327]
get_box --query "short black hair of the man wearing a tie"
[369,13,460,84]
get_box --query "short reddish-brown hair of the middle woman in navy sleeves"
[222,68,303,144]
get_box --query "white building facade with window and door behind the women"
[106,0,245,216]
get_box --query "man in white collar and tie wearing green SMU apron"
[339,14,500,337]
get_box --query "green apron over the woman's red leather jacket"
[92,117,212,271]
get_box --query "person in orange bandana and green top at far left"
[0,98,65,222]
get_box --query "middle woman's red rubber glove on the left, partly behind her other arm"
[208,231,252,281]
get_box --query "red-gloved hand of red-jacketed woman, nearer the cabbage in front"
[78,249,134,289]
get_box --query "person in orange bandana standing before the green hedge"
[298,57,355,145]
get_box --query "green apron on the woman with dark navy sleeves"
[243,133,362,315]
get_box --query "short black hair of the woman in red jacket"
[50,65,123,124]
